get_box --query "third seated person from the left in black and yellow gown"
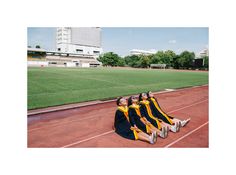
[139,93,168,138]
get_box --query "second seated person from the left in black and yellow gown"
[128,96,166,138]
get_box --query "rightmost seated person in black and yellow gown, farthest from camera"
[147,91,190,132]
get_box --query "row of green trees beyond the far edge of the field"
[98,50,209,69]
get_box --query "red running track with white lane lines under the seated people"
[28,86,209,148]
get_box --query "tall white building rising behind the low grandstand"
[56,27,102,58]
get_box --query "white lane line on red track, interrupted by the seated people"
[61,99,208,148]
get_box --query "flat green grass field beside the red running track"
[28,68,208,109]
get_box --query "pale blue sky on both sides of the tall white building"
[27,27,209,56]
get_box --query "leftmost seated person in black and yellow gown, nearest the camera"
[114,97,156,144]
